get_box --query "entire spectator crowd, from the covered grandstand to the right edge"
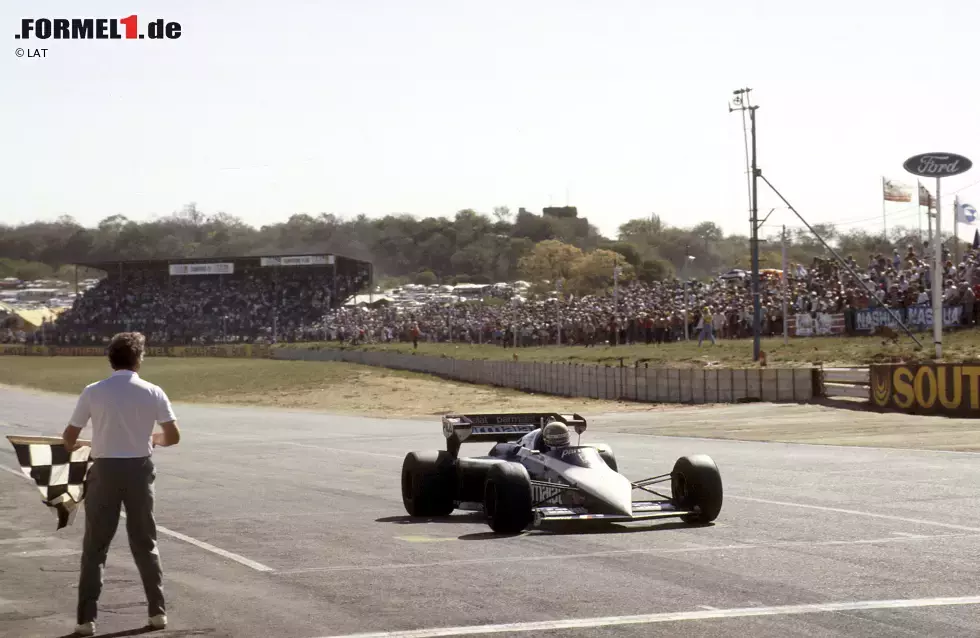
[0,242,980,346]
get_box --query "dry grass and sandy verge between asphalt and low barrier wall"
[0,356,664,418]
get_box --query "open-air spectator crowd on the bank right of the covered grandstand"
[325,247,980,347]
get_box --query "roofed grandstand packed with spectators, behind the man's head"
[45,254,373,345]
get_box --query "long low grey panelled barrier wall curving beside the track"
[273,348,819,403]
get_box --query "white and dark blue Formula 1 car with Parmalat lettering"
[401,413,722,534]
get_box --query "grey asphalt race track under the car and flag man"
[0,390,980,638]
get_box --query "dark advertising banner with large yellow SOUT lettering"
[871,363,980,418]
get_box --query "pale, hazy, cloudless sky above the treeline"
[0,0,980,242]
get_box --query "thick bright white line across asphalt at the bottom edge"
[314,596,980,638]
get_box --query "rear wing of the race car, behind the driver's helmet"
[442,412,588,456]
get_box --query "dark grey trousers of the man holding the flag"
[77,456,165,624]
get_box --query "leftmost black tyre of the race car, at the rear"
[402,452,456,516]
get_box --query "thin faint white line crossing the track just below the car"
[276,534,980,576]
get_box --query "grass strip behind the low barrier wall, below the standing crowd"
[282,330,980,367]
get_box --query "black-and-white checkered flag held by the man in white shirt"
[7,436,92,529]
